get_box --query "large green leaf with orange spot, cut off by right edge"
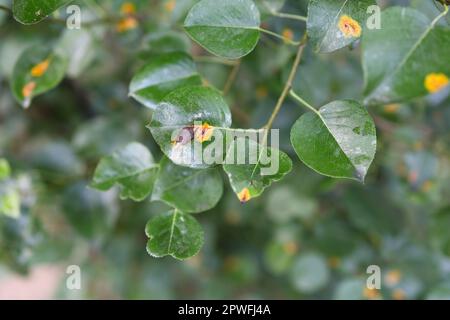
[362,7,450,104]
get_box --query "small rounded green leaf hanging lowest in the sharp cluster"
[145,210,204,260]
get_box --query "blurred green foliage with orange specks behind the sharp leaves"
[0,0,450,299]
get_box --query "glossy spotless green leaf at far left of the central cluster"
[91,142,158,201]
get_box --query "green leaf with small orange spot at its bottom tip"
[223,138,292,202]
